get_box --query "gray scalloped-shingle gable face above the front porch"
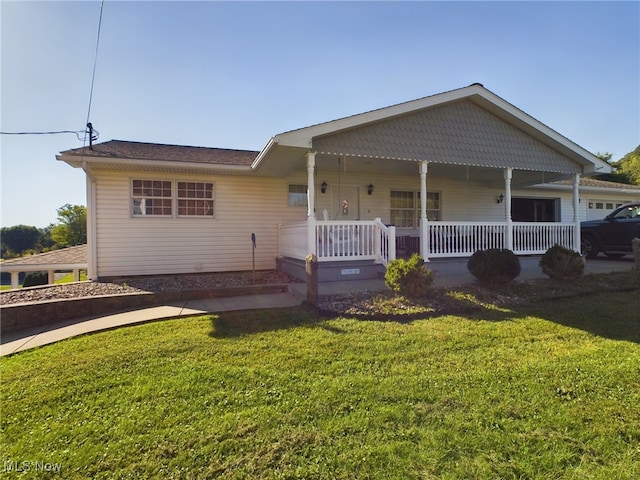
[312,100,581,174]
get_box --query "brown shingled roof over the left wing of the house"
[61,140,259,167]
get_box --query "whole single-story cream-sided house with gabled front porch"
[57,84,620,279]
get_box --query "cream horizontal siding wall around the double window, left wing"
[94,172,306,277]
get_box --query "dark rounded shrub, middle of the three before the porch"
[467,248,520,285]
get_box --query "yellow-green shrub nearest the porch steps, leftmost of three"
[384,253,433,298]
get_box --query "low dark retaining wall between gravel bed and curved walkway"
[0,284,288,335]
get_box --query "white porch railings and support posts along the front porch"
[278,156,580,272]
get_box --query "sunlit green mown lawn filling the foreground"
[0,284,640,479]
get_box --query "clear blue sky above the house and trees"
[0,0,640,228]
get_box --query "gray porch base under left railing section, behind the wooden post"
[276,257,385,282]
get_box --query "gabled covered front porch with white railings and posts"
[254,84,611,278]
